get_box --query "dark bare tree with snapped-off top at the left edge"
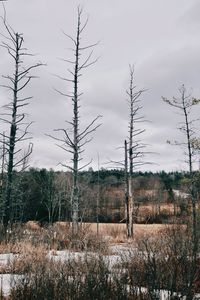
[0,13,42,227]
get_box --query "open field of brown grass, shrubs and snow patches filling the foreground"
[0,221,200,300]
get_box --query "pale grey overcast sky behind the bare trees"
[0,0,200,171]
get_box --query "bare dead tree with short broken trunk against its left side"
[125,65,144,237]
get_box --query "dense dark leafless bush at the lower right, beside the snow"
[119,225,200,299]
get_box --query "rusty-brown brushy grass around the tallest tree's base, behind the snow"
[0,221,108,253]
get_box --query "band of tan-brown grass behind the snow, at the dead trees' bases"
[0,221,186,254]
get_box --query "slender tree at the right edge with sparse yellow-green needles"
[162,84,200,297]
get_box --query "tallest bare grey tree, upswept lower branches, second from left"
[51,7,100,234]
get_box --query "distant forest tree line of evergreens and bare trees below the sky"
[1,168,197,223]
